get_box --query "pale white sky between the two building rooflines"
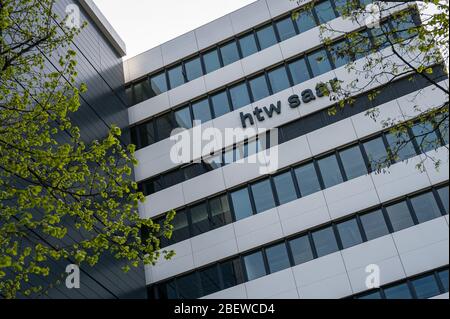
[94,0,255,59]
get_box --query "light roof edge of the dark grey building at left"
[79,0,127,57]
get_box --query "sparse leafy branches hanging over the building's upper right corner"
[291,0,449,171]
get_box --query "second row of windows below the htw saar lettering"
[157,116,448,247]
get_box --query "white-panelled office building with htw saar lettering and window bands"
[124,0,449,299]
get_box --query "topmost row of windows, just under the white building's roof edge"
[127,0,371,105]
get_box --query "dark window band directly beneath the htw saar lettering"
[139,66,445,196]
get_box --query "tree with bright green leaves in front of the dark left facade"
[0,0,174,298]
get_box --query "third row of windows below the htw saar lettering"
[151,185,448,299]
